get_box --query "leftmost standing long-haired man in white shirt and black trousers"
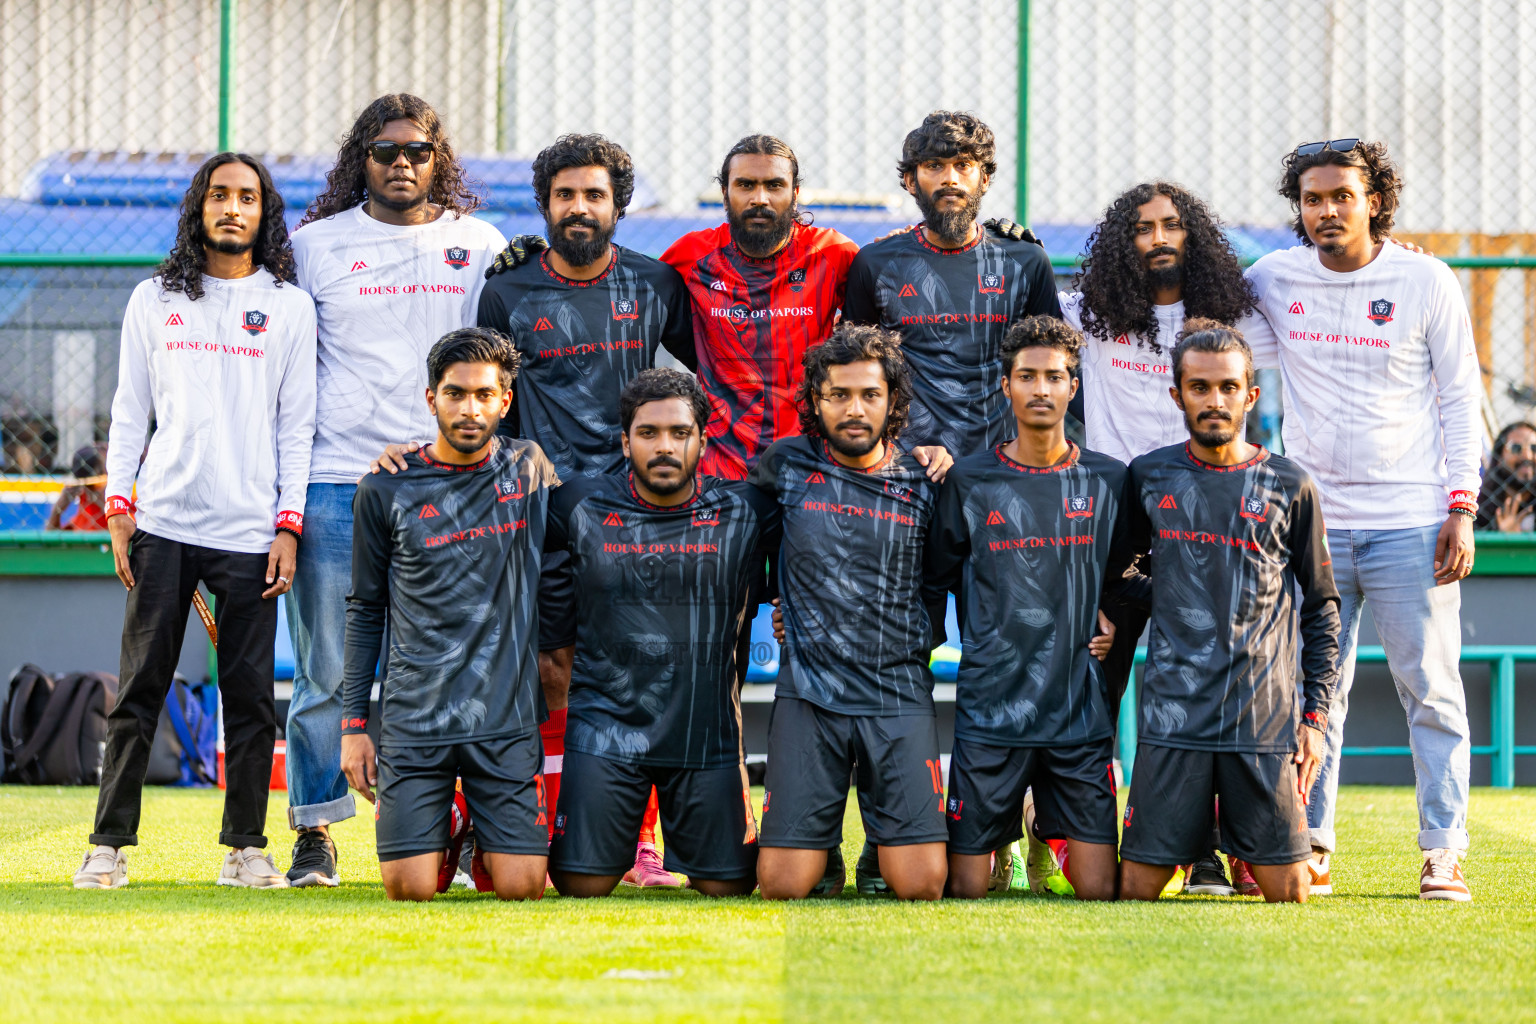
[74,154,315,889]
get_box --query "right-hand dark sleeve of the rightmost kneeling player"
[1290,477,1339,732]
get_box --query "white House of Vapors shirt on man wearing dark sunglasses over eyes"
[293,206,507,484]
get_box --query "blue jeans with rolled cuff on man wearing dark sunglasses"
[287,484,358,829]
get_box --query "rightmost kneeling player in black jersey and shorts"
[1120,319,1339,903]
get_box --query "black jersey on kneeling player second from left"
[548,474,779,768]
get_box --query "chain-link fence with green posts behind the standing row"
[0,0,1536,530]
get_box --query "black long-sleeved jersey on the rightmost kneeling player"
[1129,442,1339,752]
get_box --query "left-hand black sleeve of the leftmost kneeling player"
[341,477,393,734]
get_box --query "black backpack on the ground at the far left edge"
[0,665,117,786]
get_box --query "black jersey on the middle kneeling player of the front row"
[750,438,943,715]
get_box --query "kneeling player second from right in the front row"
[928,316,1146,900]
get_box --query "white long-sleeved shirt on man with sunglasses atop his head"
[1247,244,1482,530]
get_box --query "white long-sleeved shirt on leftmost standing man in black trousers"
[106,270,315,553]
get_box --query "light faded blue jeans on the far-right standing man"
[1307,527,1471,851]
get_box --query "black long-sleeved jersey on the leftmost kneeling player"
[343,438,559,745]
